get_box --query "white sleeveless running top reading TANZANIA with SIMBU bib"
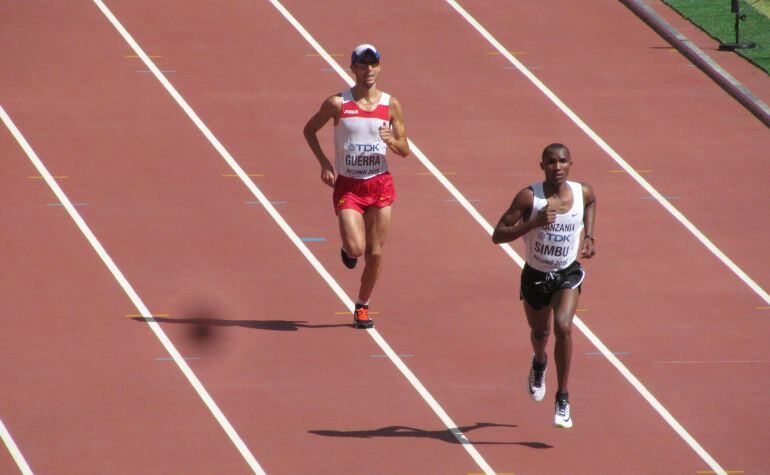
[524,181,583,272]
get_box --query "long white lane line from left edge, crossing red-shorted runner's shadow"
[0,105,265,475]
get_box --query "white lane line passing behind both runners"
[270,0,722,473]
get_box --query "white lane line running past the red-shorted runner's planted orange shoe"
[93,0,495,475]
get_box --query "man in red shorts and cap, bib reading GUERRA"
[304,44,409,328]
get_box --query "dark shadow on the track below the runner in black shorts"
[308,422,553,449]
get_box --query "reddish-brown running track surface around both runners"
[0,0,770,474]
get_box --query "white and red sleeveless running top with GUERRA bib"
[334,89,390,179]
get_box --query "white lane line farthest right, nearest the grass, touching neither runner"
[445,0,770,303]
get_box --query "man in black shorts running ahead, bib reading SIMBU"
[492,144,596,428]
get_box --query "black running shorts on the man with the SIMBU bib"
[520,261,586,310]
